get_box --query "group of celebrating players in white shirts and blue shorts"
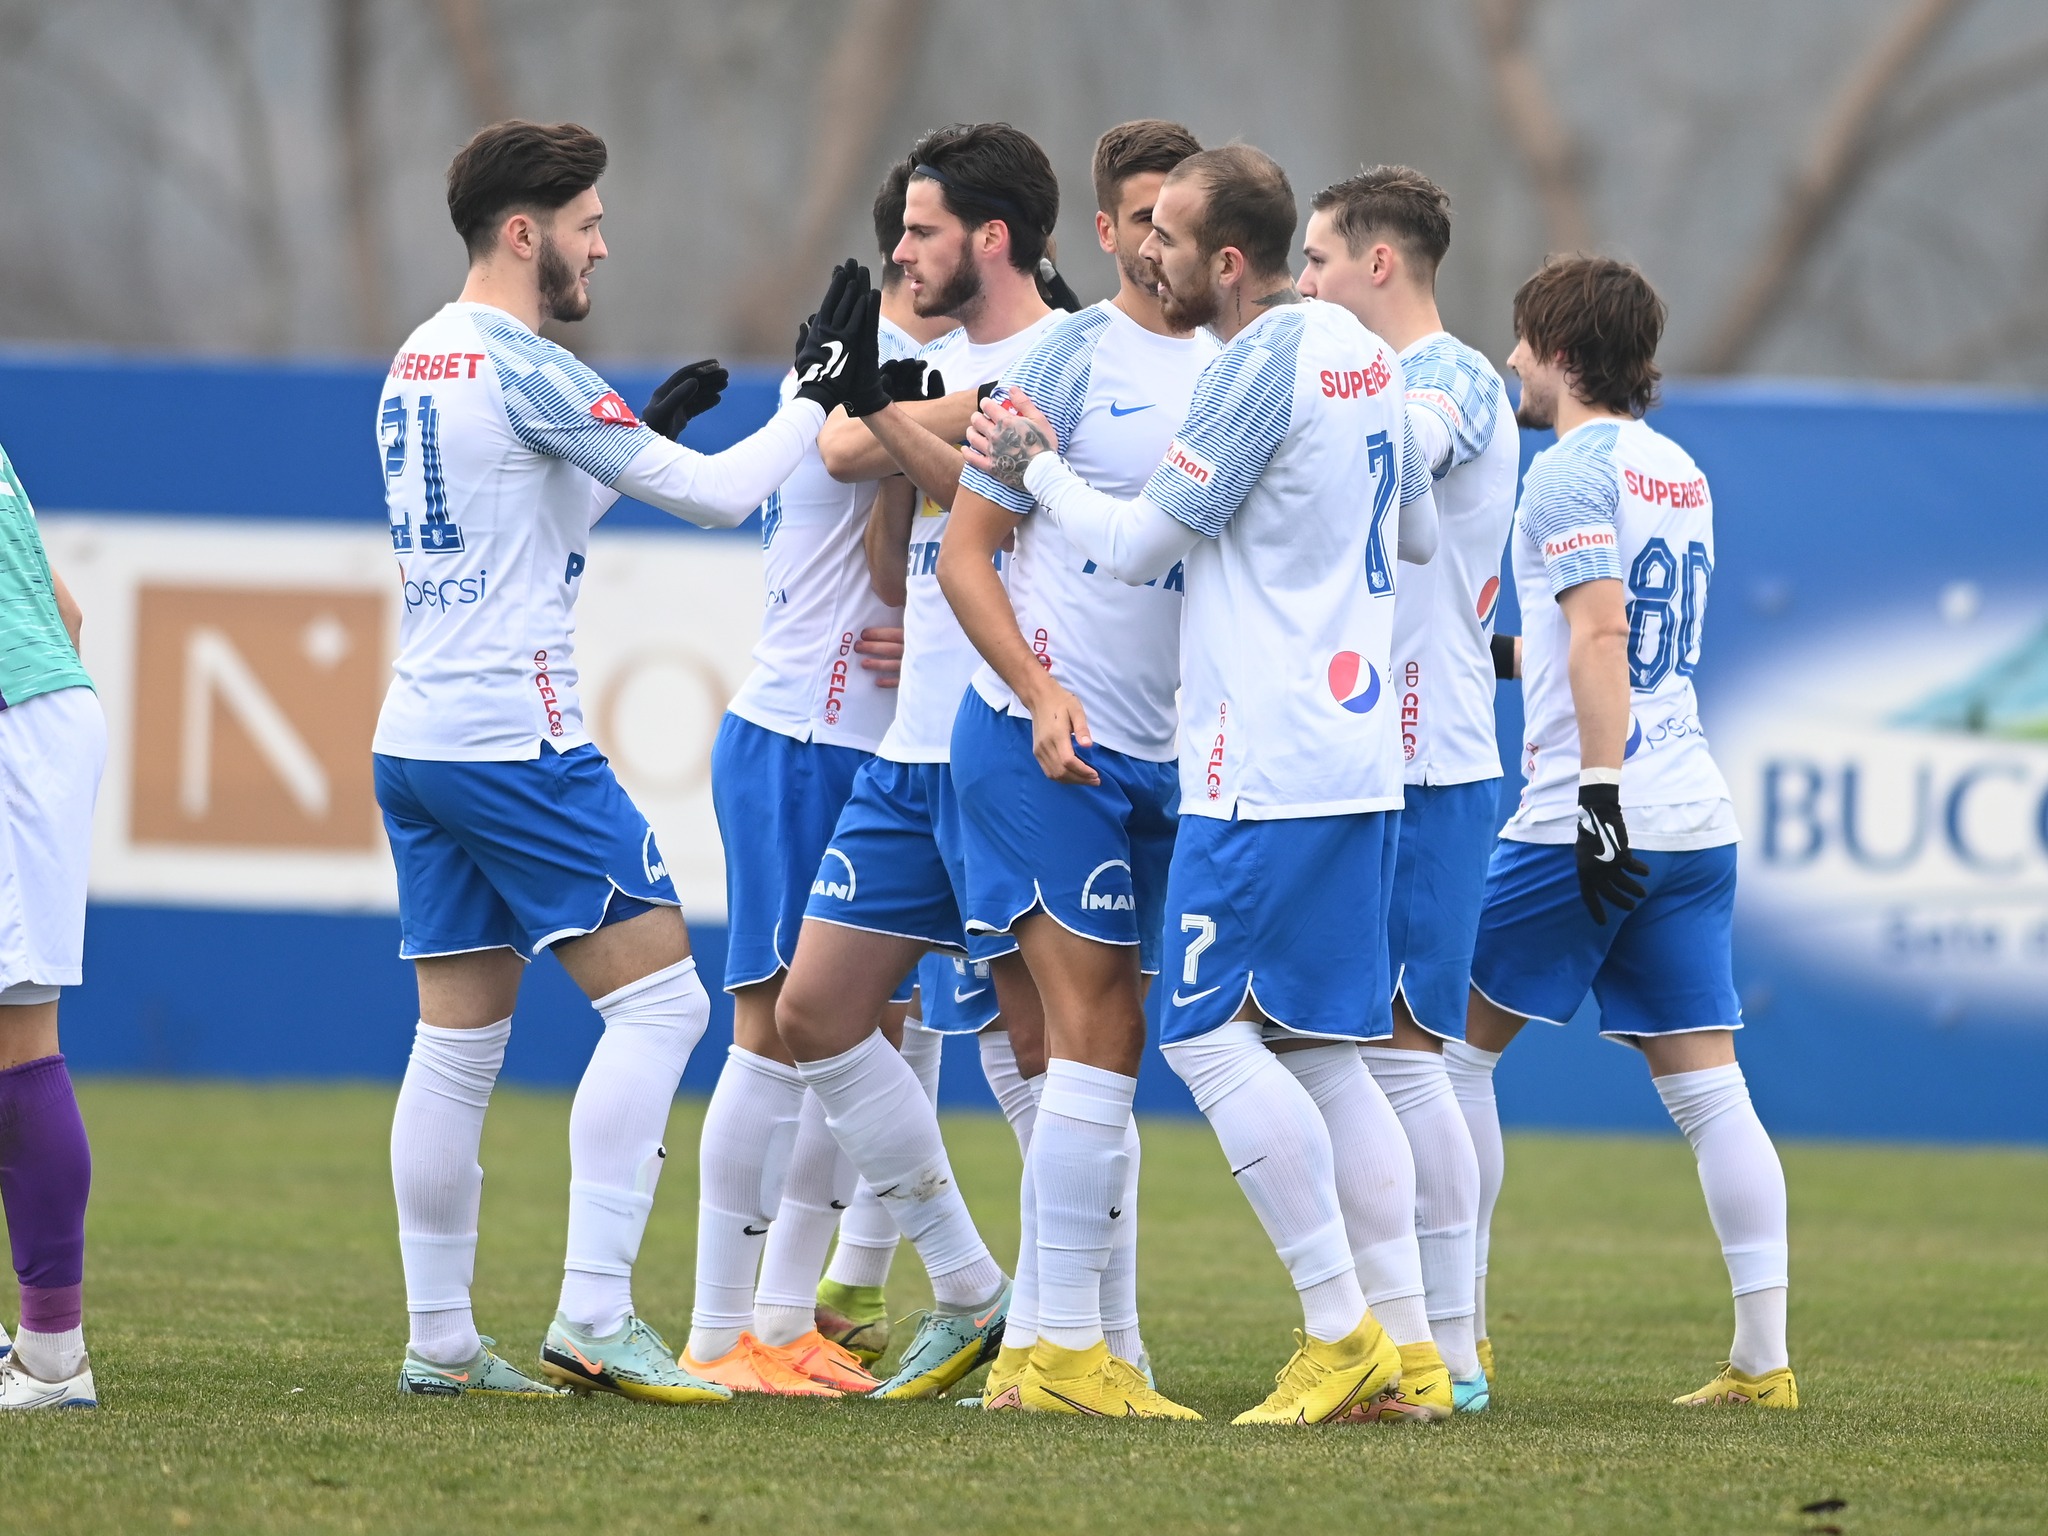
[0,119,1798,1425]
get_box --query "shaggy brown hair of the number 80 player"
[1516,256,1667,416]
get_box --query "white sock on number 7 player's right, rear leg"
[1280,1044,1430,1343]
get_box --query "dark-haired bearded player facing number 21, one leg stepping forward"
[776,123,1059,1397]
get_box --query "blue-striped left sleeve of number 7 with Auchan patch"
[1145,315,1300,539]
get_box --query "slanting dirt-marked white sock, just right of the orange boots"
[797,1030,1004,1311]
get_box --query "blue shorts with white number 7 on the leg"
[1159,811,1401,1044]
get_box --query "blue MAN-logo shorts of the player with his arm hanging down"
[952,688,1180,975]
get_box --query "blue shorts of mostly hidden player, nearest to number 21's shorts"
[711,715,868,991]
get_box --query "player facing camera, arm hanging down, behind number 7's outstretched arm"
[938,119,1217,1417]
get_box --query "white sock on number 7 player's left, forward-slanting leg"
[1165,1020,1366,1343]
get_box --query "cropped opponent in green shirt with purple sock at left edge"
[0,453,106,1413]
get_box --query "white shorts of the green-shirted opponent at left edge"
[0,688,106,1004]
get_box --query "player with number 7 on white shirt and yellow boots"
[971,145,1450,1423]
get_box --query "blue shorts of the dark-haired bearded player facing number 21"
[803,758,1016,961]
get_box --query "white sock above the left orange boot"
[688,1044,803,1362]
